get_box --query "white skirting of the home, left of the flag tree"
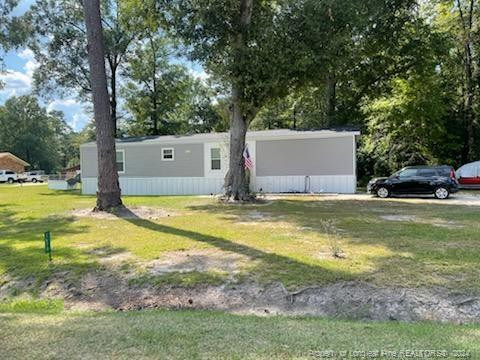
[82,177,223,195]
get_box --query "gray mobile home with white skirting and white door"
[80,130,360,195]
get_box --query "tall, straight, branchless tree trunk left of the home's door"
[83,0,122,211]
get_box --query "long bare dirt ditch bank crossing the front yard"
[48,272,480,323]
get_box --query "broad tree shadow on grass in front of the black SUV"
[185,199,480,289]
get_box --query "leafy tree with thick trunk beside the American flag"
[159,0,430,199]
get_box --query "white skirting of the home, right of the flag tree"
[255,175,357,194]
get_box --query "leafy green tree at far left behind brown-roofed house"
[0,96,72,172]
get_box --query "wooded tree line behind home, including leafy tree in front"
[0,0,480,186]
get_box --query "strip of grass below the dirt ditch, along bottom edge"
[0,307,480,359]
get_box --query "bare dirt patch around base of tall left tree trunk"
[71,206,176,220]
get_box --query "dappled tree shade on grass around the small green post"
[0,206,101,296]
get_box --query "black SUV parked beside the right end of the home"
[367,165,458,199]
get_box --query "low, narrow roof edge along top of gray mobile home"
[82,128,360,146]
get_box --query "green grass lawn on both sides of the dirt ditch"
[0,186,480,359]
